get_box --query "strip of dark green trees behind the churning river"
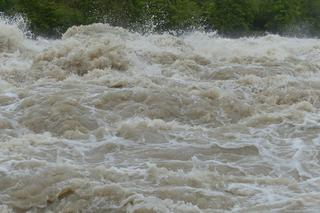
[0,0,320,36]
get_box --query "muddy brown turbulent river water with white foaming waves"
[0,17,320,213]
